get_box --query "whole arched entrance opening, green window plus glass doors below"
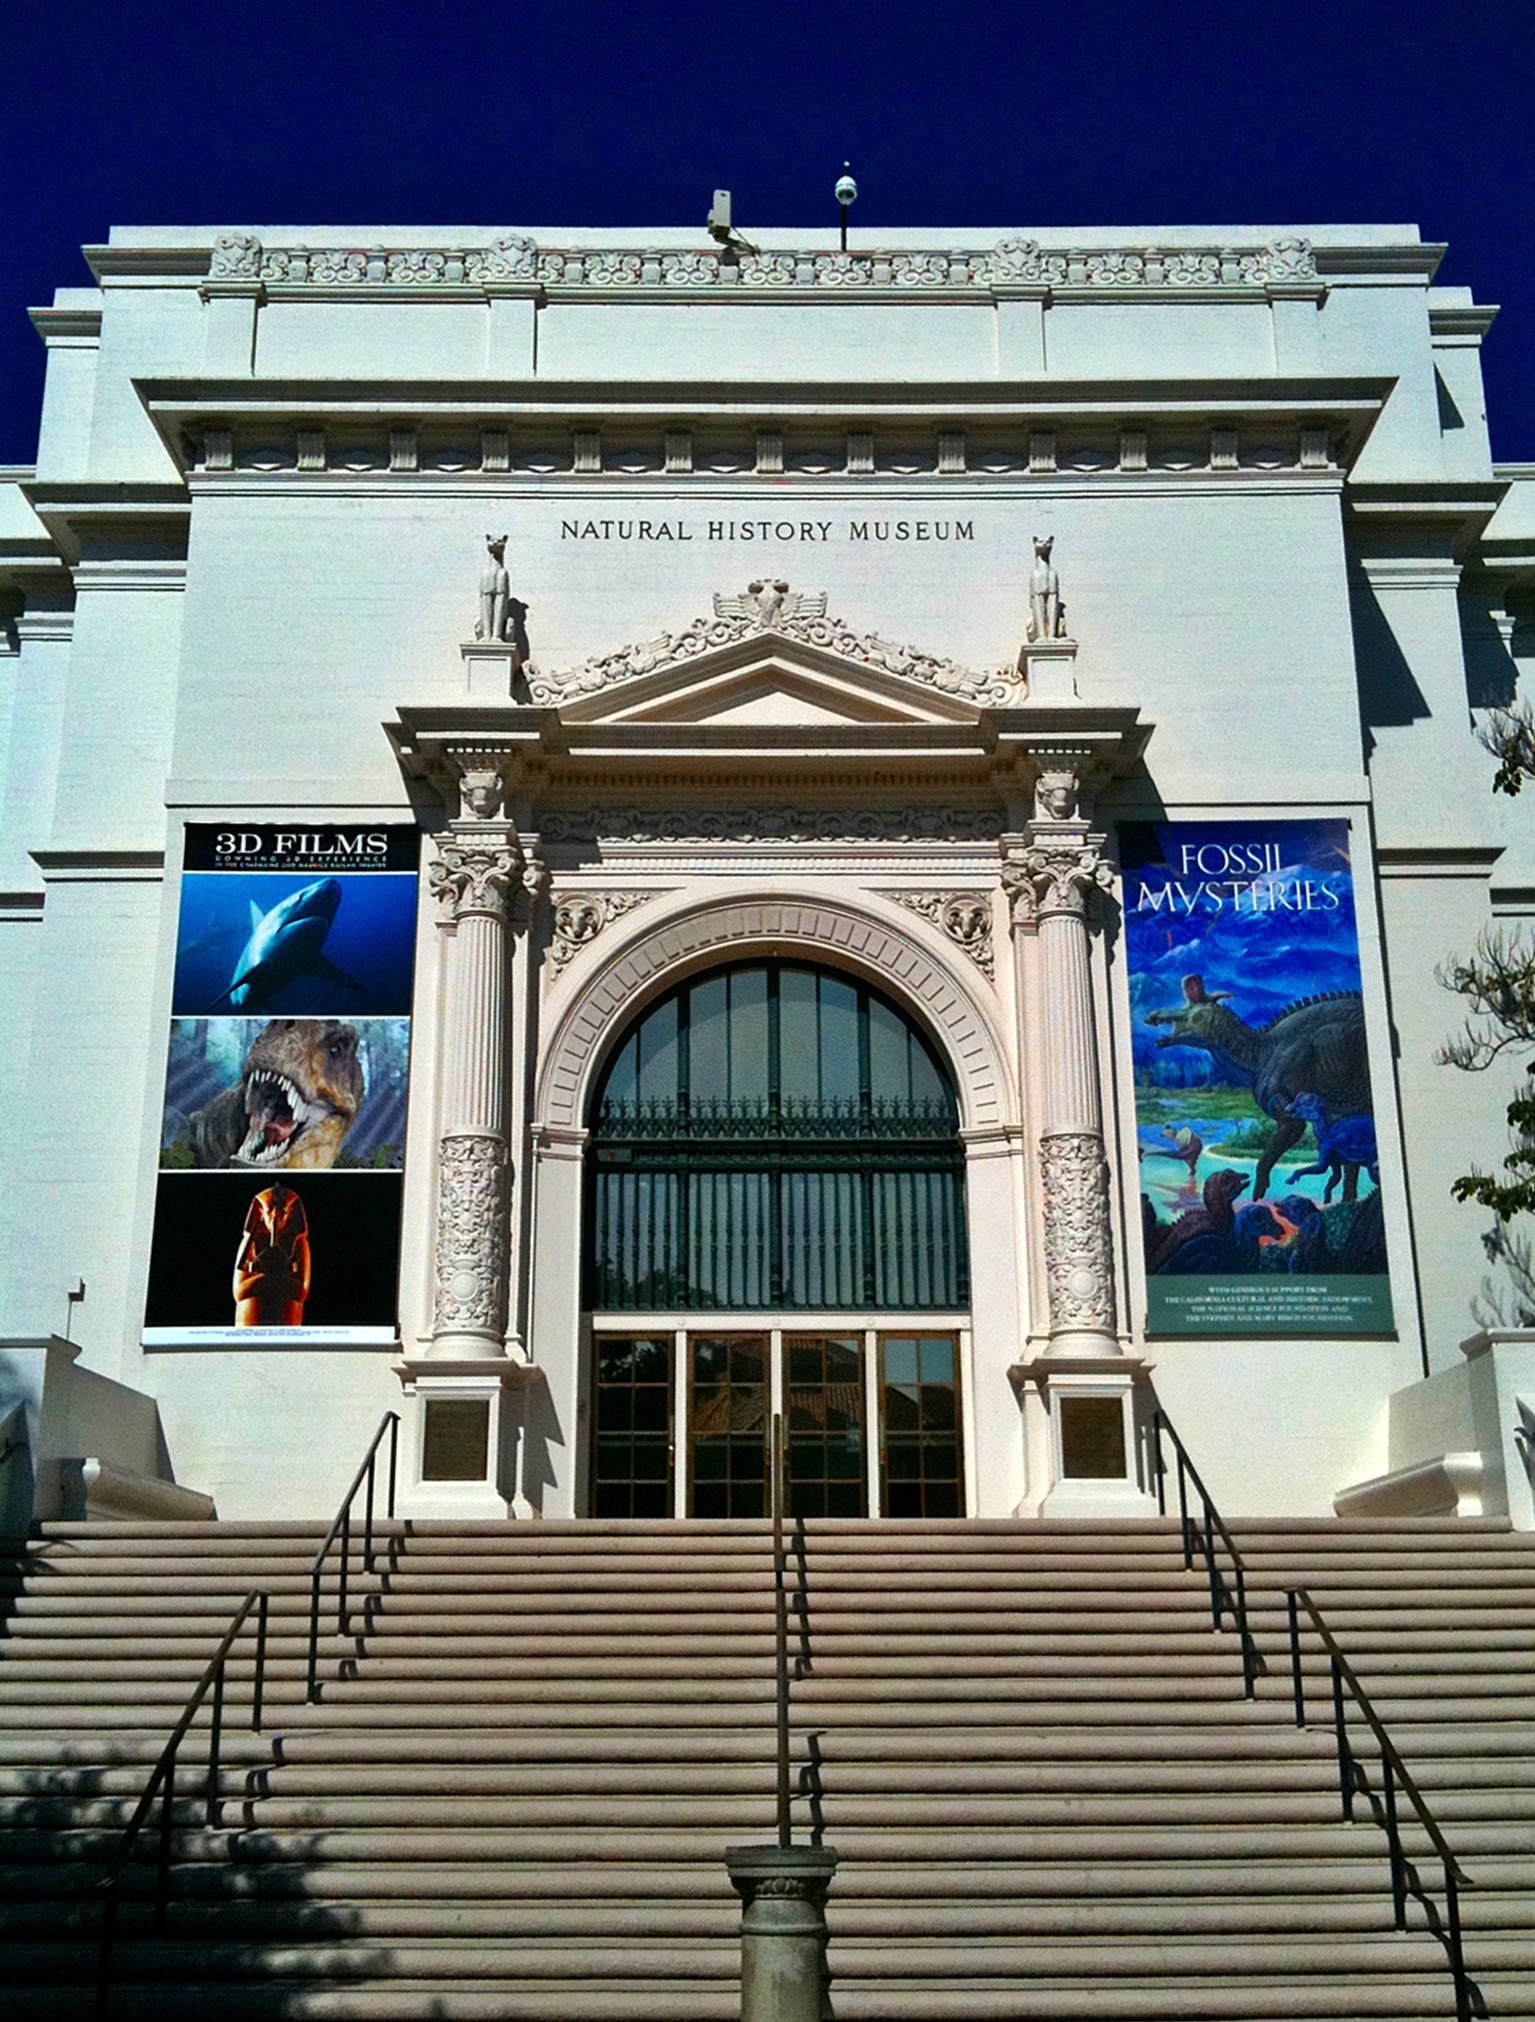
[582,958,969,1517]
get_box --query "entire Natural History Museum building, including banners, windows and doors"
[0,226,1535,1527]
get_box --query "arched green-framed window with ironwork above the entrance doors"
[584,962,969,1312]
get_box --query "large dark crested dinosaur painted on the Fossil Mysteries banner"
[1147,977,1371,1201]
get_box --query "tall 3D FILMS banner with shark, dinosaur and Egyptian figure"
[144,823,419,1347]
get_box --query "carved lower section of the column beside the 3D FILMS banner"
[431,1132,510,1361]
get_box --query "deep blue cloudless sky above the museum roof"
[0,0,1535,463]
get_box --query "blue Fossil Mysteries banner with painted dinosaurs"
[1120,821,1391,1335]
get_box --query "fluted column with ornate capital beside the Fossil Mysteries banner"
[1001,772,1120,1355]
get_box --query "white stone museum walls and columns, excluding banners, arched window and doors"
[0,226,1535,1517]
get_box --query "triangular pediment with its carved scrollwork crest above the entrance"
[530,582,1021,728]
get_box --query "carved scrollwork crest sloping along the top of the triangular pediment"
[528,582,1021,708]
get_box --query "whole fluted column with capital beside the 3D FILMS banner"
[431,823,526,1359]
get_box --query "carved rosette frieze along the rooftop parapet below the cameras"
[208,233,1321,295]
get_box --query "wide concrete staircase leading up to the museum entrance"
[0,1521,1535,2022]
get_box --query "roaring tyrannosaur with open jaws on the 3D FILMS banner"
[184,1017,368,1171]
